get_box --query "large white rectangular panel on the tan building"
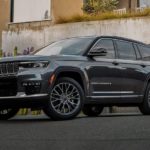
[14,0,51,22]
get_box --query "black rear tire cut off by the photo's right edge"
[139,84,150,115]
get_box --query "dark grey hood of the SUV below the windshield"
[0,55,87,62]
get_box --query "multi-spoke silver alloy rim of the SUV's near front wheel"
[50,82,81,115]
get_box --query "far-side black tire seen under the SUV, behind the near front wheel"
[82,105,103,117]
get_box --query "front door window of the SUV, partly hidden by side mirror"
[92,39,115,59]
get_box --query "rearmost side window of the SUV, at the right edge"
[138,45,150,61]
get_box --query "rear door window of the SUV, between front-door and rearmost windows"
[116,41,136,60]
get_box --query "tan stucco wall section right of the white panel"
[52,0,83,20]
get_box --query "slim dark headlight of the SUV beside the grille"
[19,61,49,69]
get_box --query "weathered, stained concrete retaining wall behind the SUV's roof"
[3,17,150,51]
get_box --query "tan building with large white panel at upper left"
[0,0,83,49]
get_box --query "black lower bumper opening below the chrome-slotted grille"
[0,78,18,97]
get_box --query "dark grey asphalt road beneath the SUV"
[0,114,150,150]
